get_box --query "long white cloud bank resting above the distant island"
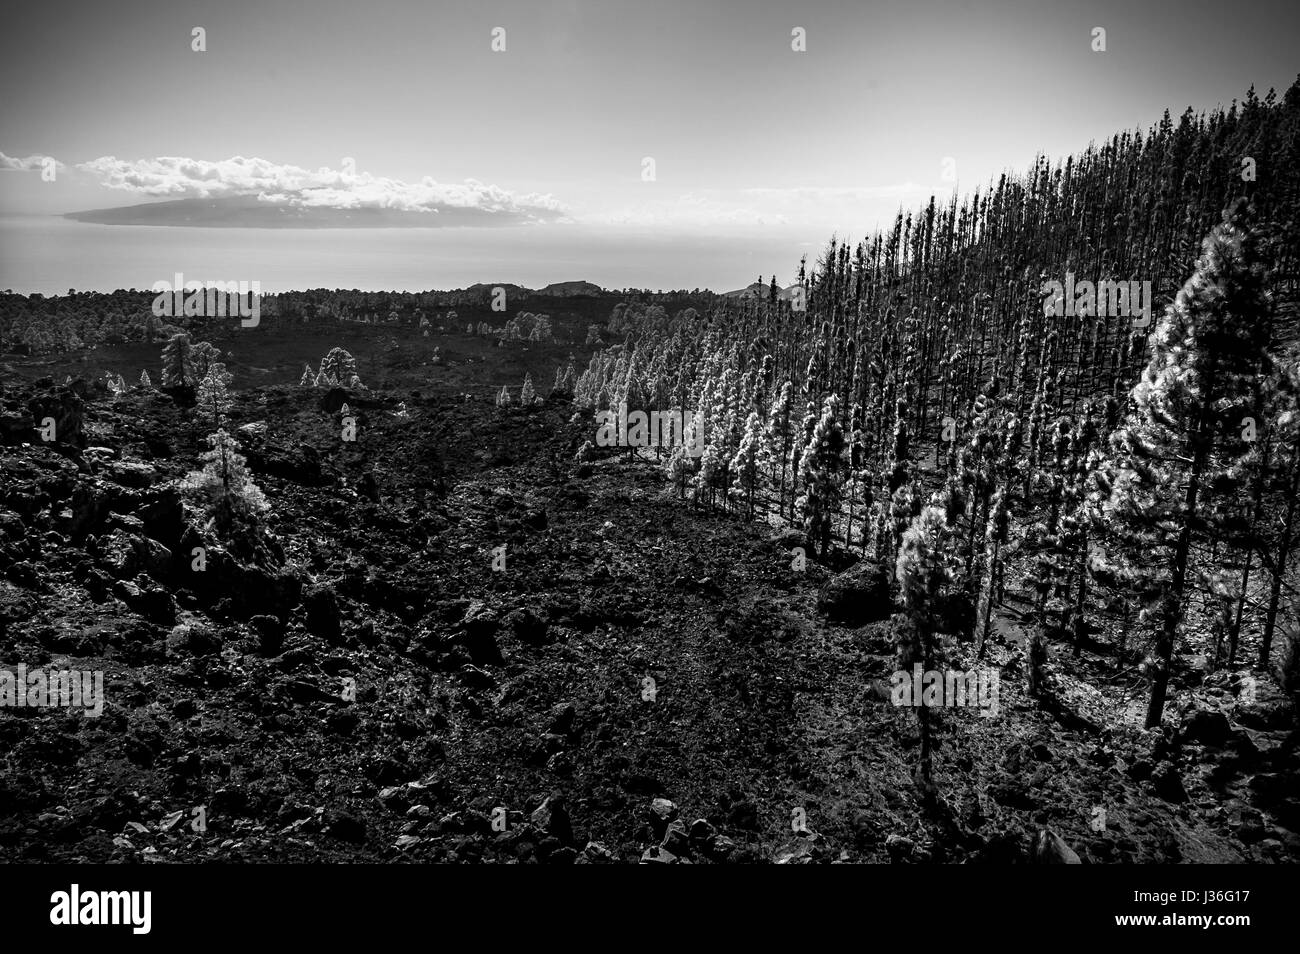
[77,156,566,221]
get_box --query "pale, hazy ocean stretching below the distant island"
[0,214,811,295]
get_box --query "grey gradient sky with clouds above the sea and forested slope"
[0,0,1300,283]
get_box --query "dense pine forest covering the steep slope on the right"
[576,83,1300,753]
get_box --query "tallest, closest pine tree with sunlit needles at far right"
[1099,204,1270,728]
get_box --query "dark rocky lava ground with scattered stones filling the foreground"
[0,330,1300,863]
